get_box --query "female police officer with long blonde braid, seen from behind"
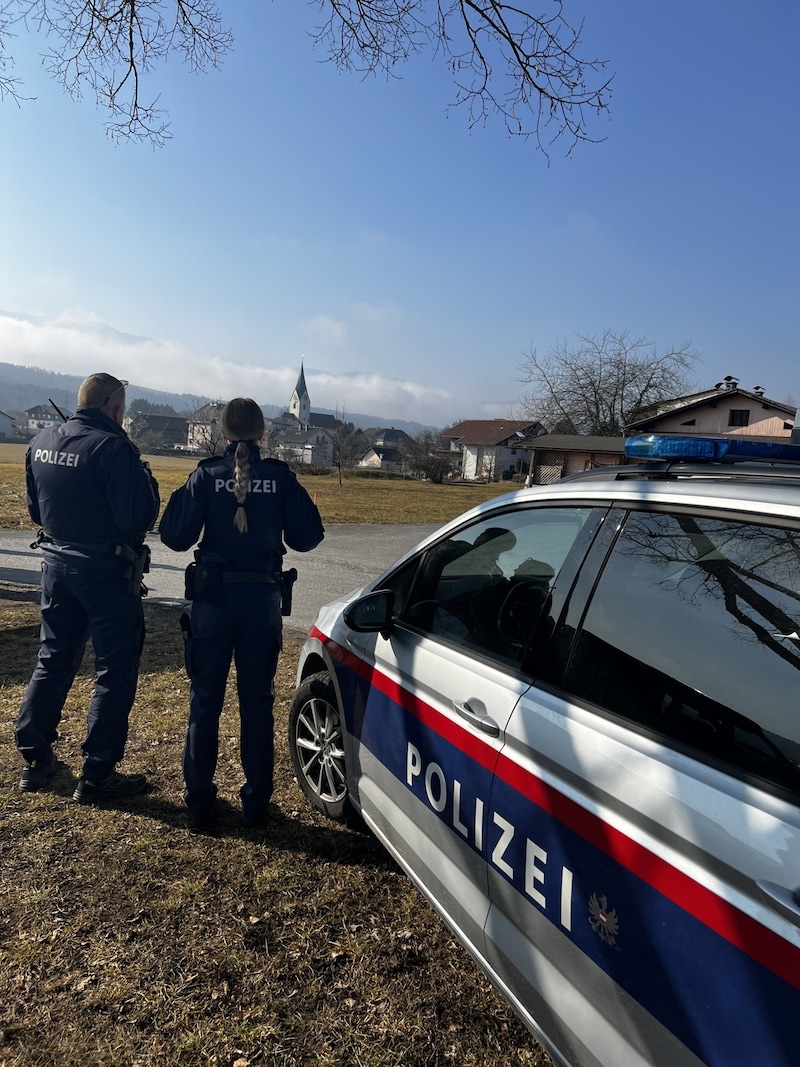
[160,397,324,828]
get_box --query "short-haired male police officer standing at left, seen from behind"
[15,373,159,803]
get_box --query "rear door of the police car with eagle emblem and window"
[485,508,800,1067]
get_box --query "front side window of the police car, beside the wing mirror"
[398,508,592,665]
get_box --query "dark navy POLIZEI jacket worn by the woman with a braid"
[160,442,324,573]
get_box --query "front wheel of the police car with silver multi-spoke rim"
[289,671,352,821]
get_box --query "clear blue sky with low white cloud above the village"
[0,0,800,426]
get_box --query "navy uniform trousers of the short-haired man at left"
[15,553,144,781]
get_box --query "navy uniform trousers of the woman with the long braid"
[183,584,282,816]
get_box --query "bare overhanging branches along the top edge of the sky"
[0,0,611,156]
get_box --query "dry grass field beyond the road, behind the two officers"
[0,445,514,529]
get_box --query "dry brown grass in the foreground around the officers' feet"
[0,589,549,1067]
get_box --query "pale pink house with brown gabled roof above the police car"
[628,375,797,440]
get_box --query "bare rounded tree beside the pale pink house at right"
[519,330,698,436]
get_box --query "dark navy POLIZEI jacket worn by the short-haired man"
[26,408,160,555]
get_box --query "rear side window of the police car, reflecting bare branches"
[564,512,800,794]
